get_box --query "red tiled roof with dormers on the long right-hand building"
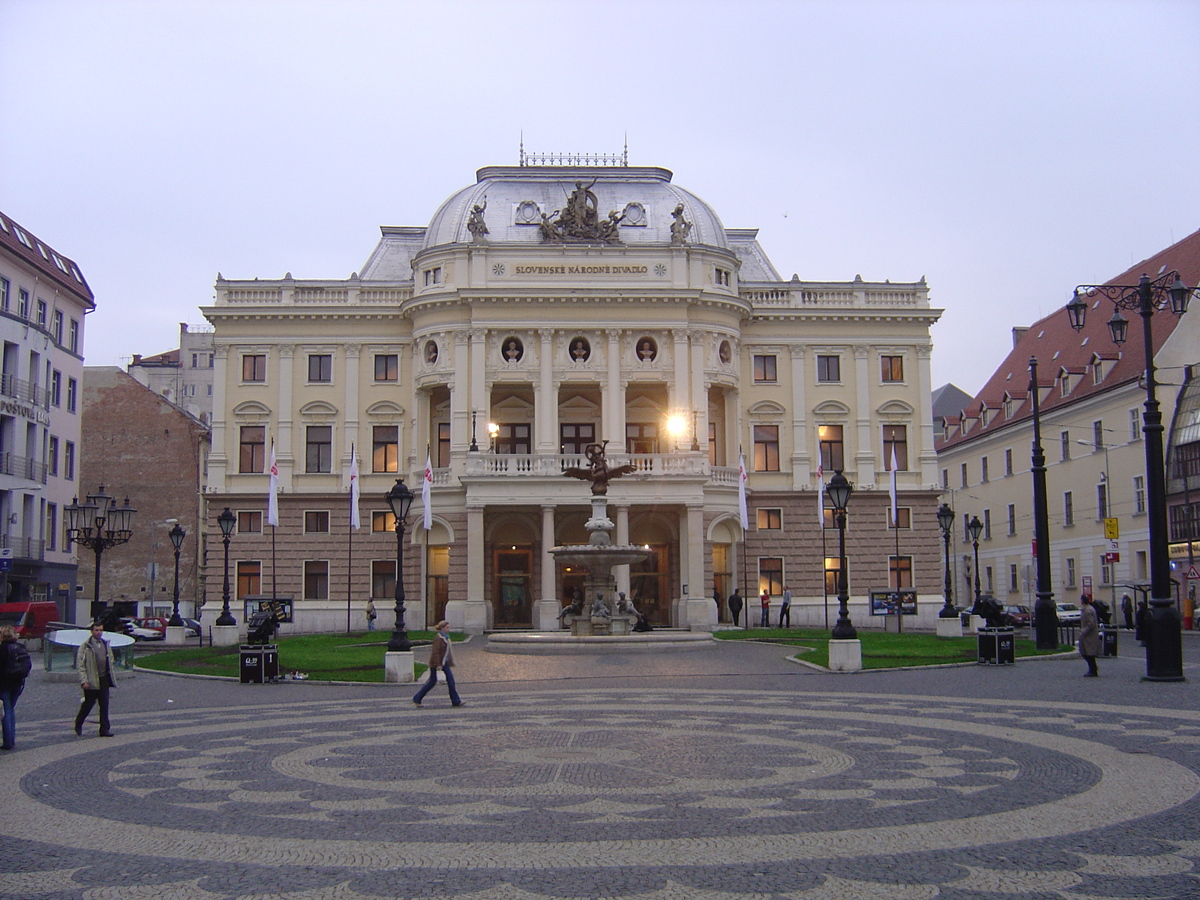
[937,226,1200,450]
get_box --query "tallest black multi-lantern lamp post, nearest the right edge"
[1067,271,1192,682]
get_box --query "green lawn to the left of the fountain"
[130,631,451,683]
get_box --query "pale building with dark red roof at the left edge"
[0,214,96,614]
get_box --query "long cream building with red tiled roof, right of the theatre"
[937,232,1200,618]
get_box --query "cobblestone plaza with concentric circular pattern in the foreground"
[0,635,1200,900]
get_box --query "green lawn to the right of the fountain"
[713,628,1072,668]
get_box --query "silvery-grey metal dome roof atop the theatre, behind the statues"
[425,166,730,248]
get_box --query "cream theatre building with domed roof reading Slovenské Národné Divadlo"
[203,156,942,631]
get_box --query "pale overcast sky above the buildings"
[0,0,1200,394]
